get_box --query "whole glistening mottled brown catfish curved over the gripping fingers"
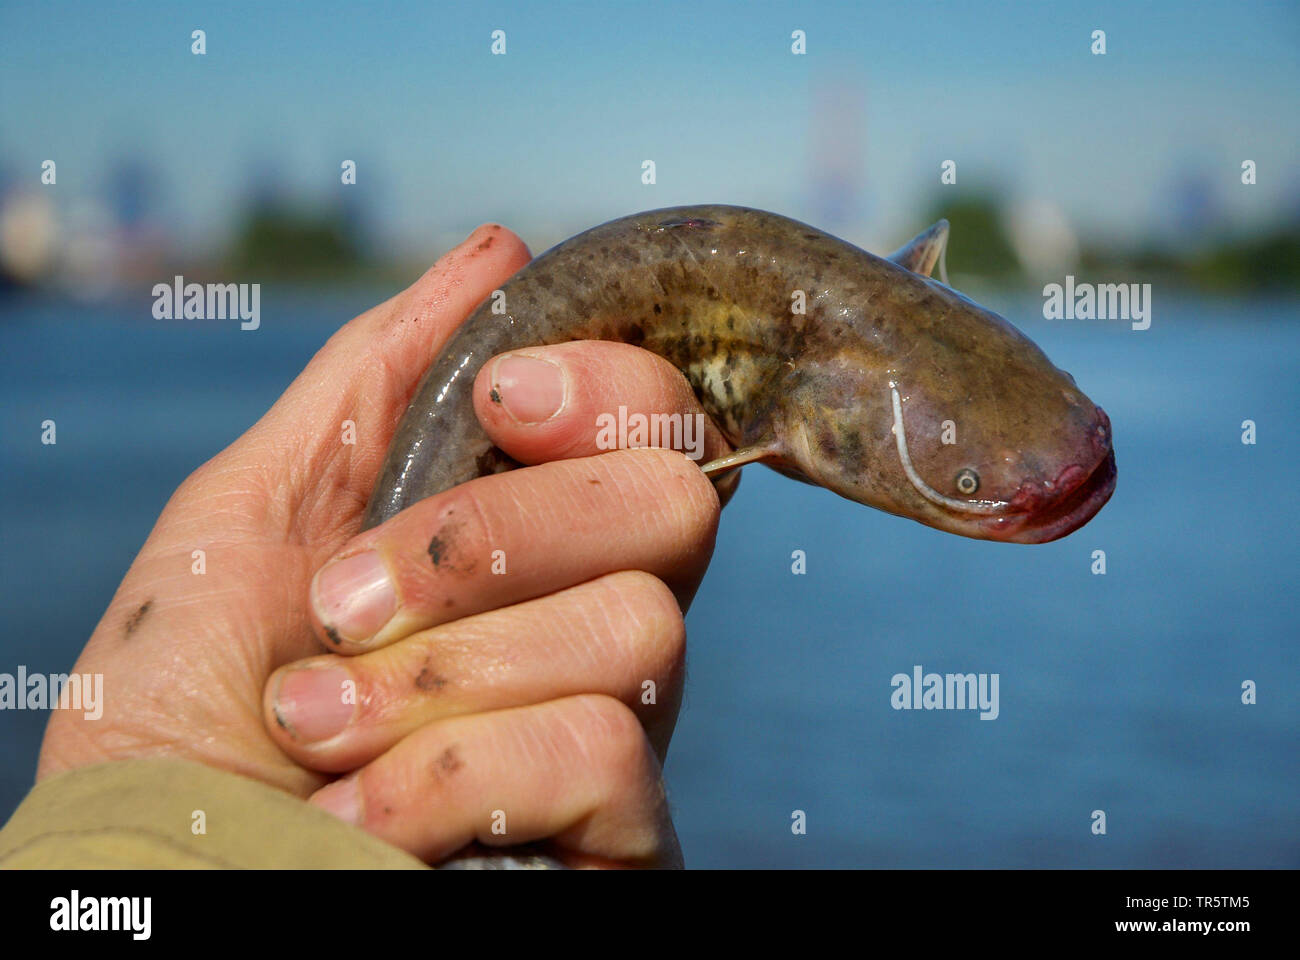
[365,206,1115,542]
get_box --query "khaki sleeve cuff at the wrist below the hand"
[0,758,424,869]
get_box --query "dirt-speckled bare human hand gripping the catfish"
[38,226,725,864]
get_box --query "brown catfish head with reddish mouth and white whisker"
[779,264,1115,544]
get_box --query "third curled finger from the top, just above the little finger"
[265,571,686,773]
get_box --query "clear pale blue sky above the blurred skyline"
[0,0,1300,257]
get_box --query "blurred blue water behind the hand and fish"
[0,291,1300,868]
